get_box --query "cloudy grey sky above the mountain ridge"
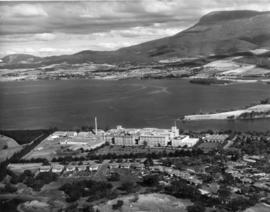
[0,0,270,57]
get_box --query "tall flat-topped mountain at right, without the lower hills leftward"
[119,11,270,59]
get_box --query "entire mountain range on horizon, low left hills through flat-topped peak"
[2,10,270,67]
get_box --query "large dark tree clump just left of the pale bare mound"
[60,180,115,202]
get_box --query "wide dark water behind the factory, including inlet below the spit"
[0,80,270,131]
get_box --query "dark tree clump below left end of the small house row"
[10,170,58,191]
